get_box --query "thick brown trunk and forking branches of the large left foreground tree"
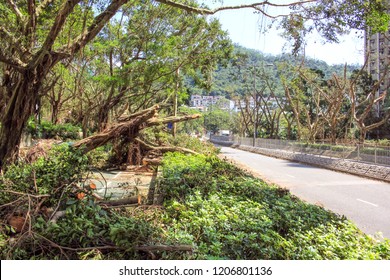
[0,0,128,170]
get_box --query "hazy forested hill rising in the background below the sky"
[187,45,361,99]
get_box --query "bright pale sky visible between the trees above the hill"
[200,0,364,64]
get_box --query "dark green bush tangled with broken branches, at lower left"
[0,144,159,259]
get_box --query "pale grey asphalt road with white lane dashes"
[221,147,390,238]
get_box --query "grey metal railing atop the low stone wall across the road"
[210,135,390,166]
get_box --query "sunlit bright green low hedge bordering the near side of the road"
[161,154,390,259]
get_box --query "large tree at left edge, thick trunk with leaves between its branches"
[0,0,131,167]
